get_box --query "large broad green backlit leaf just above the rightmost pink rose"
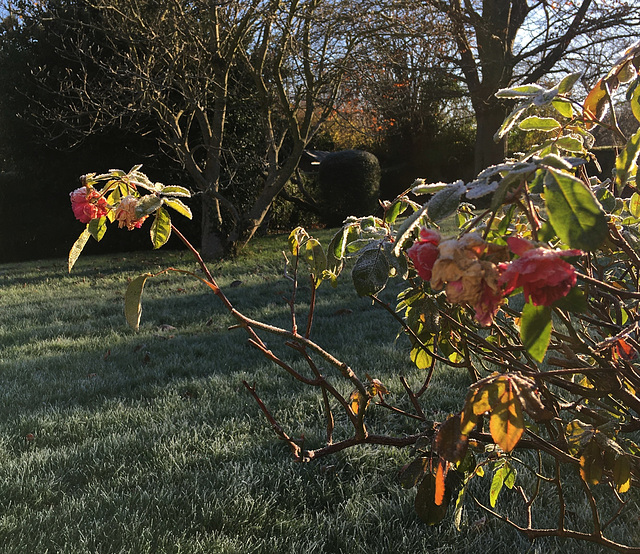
[544,169,609,250]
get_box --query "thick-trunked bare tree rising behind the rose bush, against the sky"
[425,0,640,171]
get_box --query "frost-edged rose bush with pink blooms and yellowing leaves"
[69,44,640,552]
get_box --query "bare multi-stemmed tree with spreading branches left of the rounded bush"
[7,0,360,258]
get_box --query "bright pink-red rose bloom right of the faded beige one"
[500,237,583,306]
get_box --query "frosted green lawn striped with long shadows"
[0,236,640,554]
